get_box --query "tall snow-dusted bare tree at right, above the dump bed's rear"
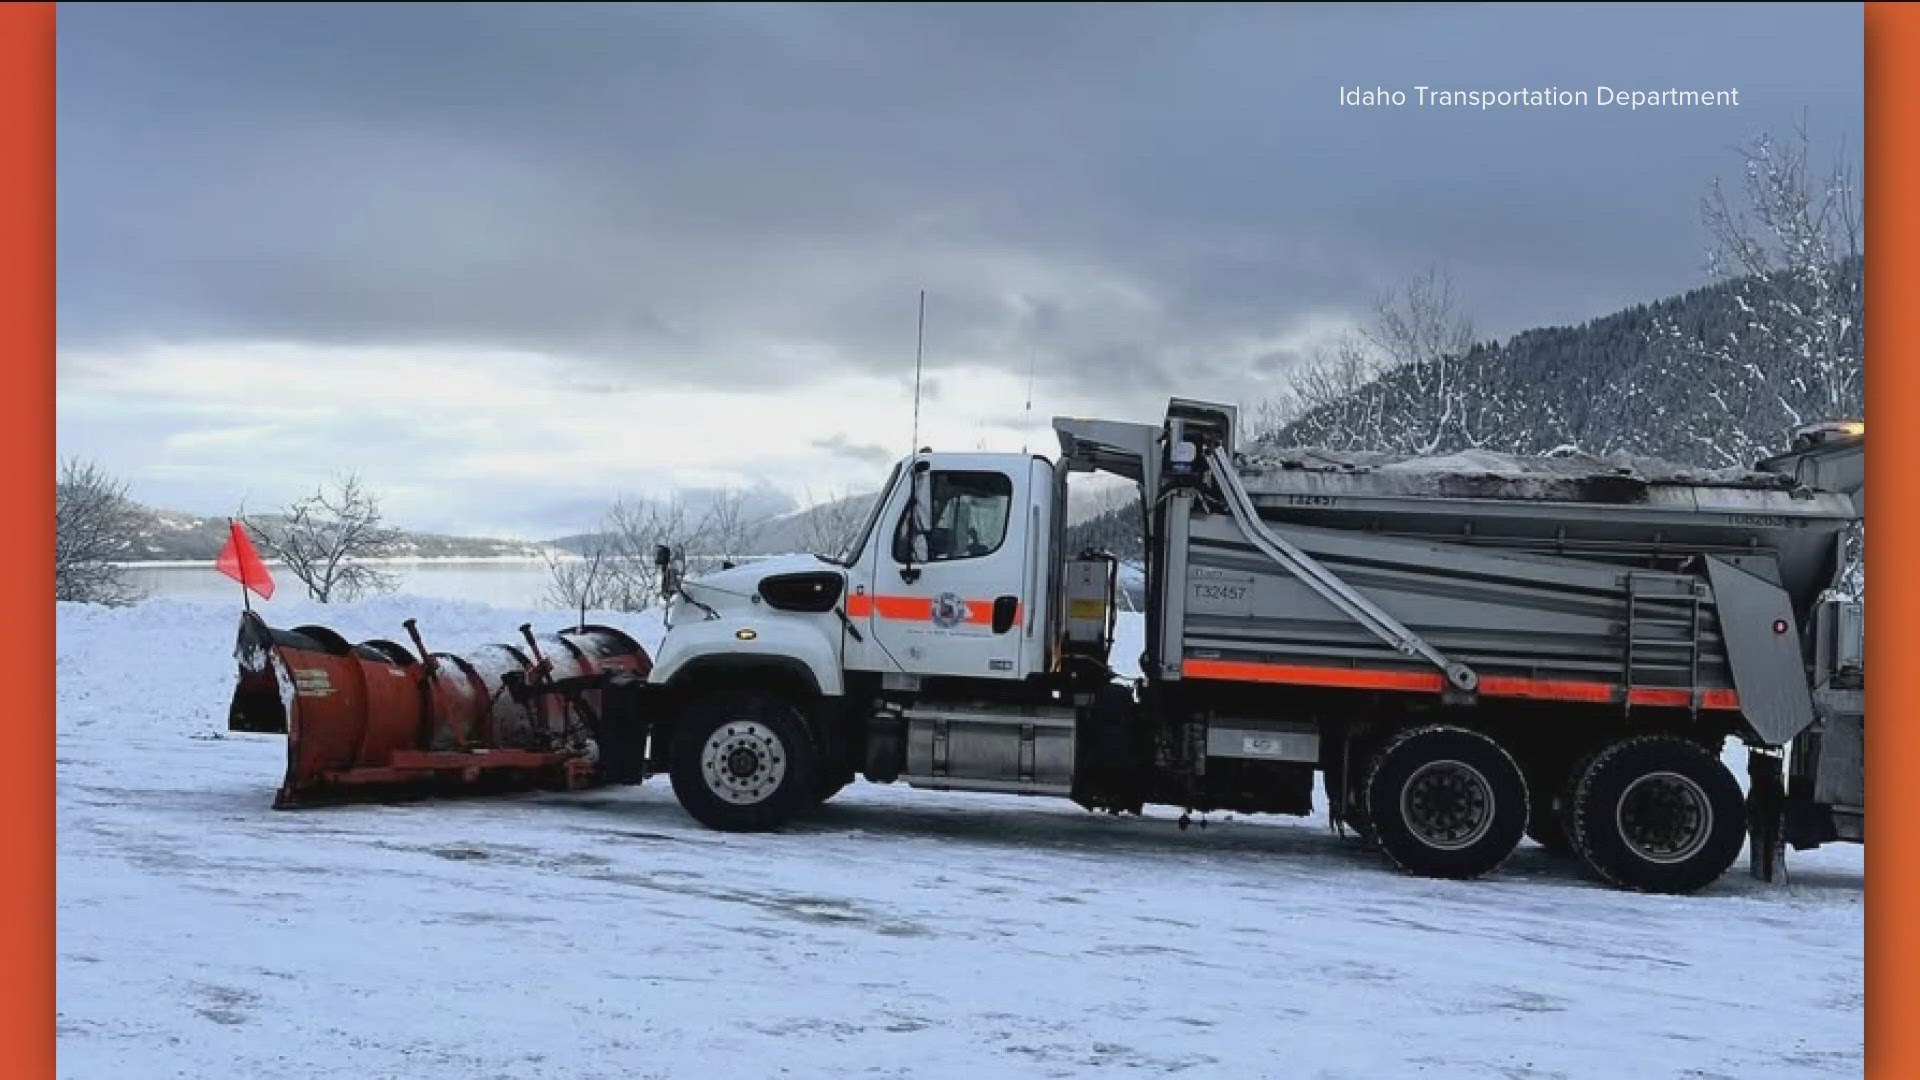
[1644,127,1866,465]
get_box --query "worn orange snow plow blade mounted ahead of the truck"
[227,611,653,807]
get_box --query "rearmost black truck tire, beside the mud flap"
[1571,734,1747,894]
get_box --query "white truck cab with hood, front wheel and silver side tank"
[647,441,1114,830]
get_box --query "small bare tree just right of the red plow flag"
[240,475,401,603]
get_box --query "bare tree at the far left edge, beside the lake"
[54,457,144,605]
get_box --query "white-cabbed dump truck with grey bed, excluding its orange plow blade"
[628,400,1864,894]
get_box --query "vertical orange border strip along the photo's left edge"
[0,4,54,1076]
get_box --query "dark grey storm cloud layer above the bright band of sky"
[60,6,1860,394]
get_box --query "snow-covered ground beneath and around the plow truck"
[58,598,1862,1080]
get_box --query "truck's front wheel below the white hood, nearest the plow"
[672,690,816,832]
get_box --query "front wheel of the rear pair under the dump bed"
[1361,724,1526,878]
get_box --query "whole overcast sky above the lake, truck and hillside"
[58,4,1862,538]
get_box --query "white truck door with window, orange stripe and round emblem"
[852,455,1031,678]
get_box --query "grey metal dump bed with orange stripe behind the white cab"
[1148,407,1855,746]
